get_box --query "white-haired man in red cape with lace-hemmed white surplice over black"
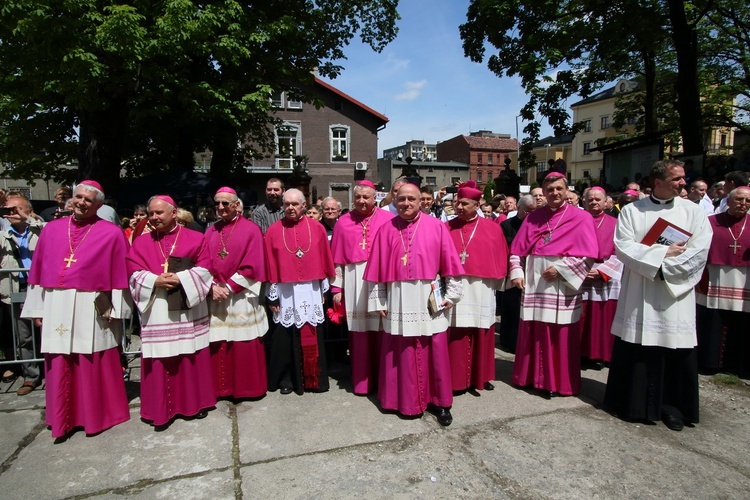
[265,189,335,395]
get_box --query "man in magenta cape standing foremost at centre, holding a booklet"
[364,184,464,425]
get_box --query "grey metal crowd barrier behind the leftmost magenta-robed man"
[0,268,141,371]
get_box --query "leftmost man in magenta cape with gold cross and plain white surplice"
[21,180,131,438]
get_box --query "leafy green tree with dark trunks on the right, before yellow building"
[461,0,746,161]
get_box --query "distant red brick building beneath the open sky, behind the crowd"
[437,130,518,187]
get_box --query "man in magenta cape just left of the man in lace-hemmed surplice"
[205,187,268,398]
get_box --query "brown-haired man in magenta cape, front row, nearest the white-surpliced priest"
[510,172,599,396]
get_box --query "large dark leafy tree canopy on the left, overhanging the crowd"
[0,0,398,192]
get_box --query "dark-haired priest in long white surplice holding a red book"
[604,160,711,430]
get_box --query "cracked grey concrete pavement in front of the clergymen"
[0,350,750,500]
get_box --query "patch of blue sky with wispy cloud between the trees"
[331,0,551,156]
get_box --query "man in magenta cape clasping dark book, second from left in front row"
[127,195,216,427]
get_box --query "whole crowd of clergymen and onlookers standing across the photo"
[0,160,750,439]
